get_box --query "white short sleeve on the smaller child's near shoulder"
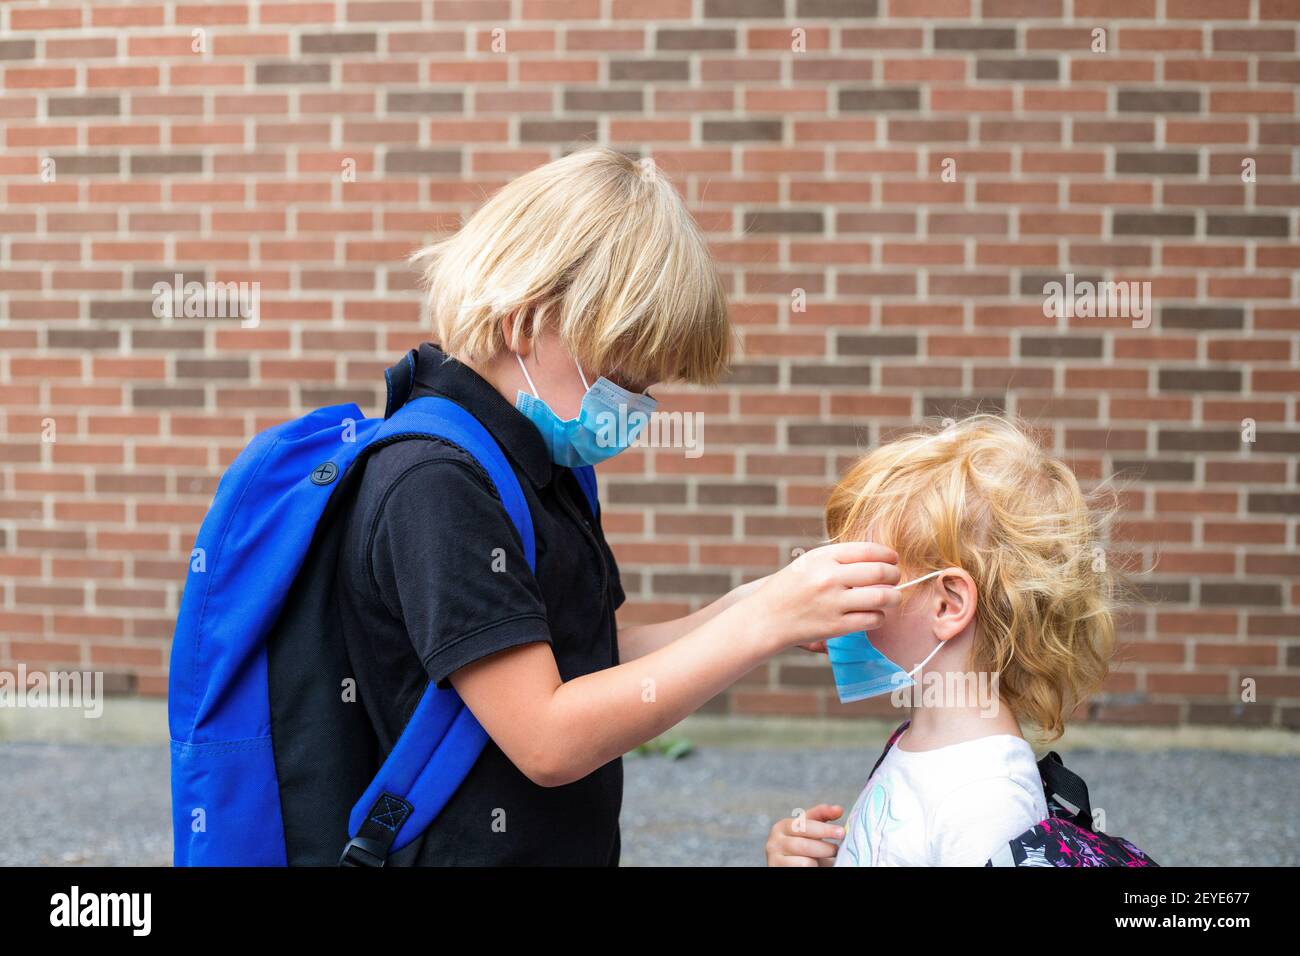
[928,777,1043,866]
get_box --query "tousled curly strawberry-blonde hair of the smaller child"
[826,415,1118,740]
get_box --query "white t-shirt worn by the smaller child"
[835,734,1048,866]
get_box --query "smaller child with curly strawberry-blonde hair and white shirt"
[767,416,1114,866]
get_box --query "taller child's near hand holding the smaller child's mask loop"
[745,542,901,648]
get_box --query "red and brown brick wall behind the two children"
[0,0,1300,727]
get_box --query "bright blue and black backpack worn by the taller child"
[168,351,598,866]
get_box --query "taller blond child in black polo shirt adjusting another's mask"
[337,148,898,865]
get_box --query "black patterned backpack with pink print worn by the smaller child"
[871,721,1160,866]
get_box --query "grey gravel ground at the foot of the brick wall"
[0,743,1300,866]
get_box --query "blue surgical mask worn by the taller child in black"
[515,352,659,468]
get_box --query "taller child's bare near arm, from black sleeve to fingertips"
[451,544,898,787]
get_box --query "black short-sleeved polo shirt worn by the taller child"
[337,345,623,866]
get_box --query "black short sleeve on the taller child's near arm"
[368,452,550,688]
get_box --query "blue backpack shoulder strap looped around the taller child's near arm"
[339,397,537,866]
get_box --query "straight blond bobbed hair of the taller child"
[411,147,731,382]
